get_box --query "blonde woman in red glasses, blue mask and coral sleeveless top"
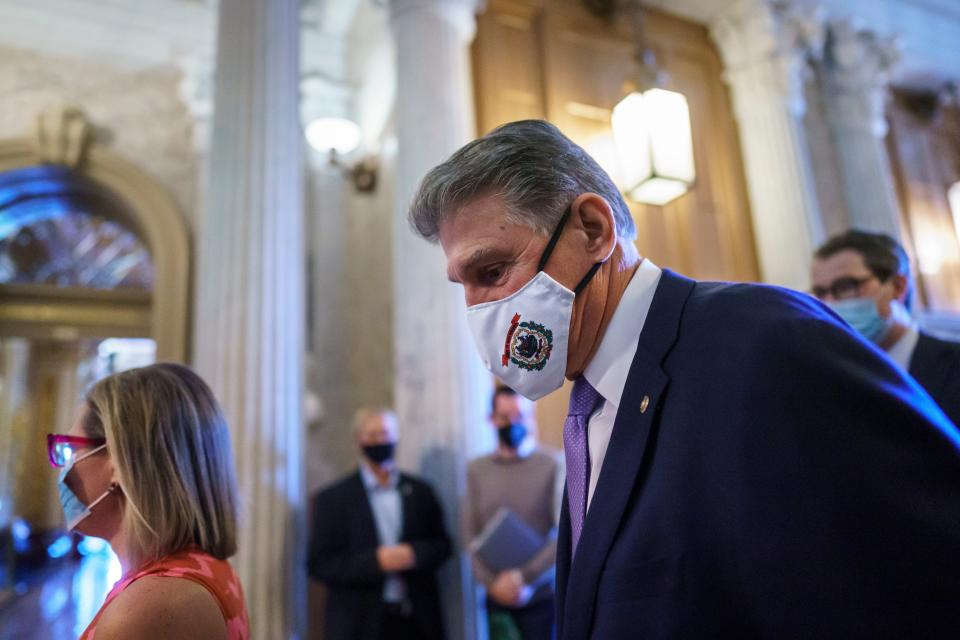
[48,364,249,640]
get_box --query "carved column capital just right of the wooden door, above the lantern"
[710,0,824,116]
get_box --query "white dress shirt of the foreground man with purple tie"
[583,260,662,509]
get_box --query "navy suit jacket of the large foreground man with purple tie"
[557,271,960,640]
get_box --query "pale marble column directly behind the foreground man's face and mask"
[390,0,492,639]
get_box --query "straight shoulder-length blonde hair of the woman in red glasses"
[84,363,237,562]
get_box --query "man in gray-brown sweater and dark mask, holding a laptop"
[462,386,563,640]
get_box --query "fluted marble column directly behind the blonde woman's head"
[195,0,306,638]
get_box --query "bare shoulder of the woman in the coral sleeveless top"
[94,576,227,640]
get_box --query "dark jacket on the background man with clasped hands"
[307,472,450,640]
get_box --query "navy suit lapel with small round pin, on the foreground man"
[557,270,694,640]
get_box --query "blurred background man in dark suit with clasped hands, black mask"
[307,409,450,640]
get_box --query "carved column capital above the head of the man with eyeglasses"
[821,20,901,138]
